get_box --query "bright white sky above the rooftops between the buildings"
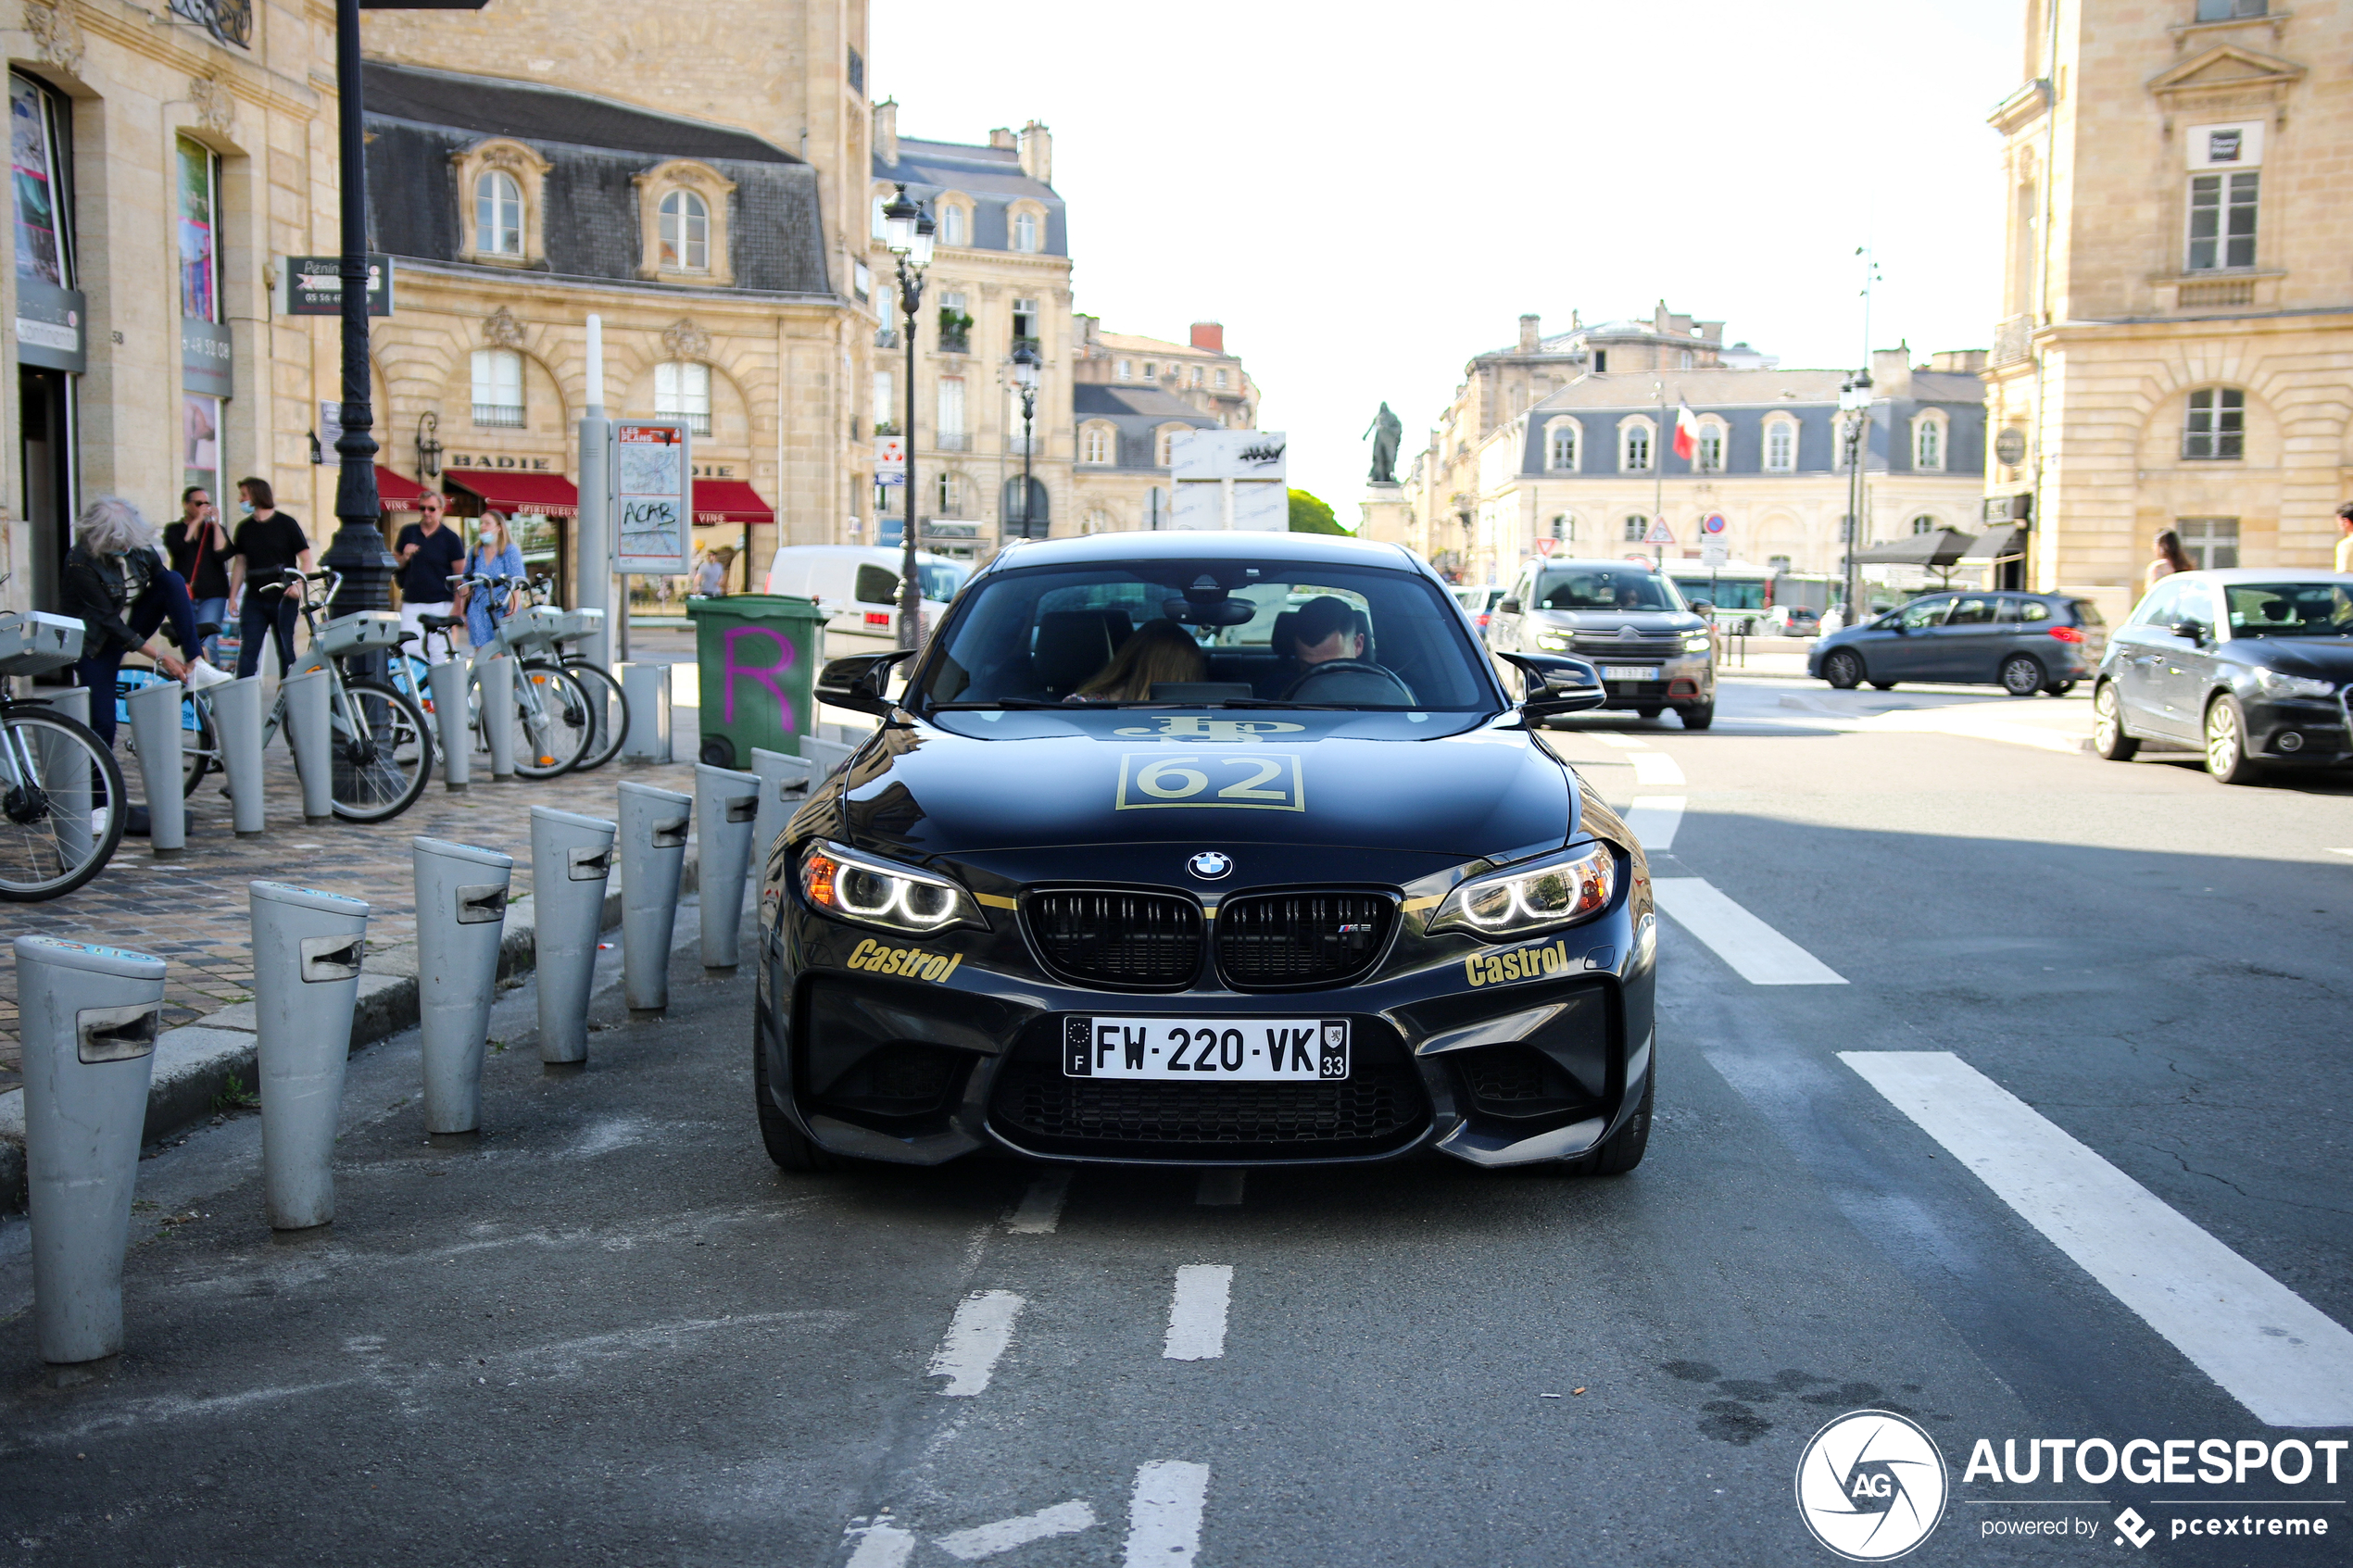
[871,0,2023,527]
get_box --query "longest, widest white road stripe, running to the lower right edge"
[1838,1051,2353,1427]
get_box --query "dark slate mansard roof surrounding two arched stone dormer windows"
[362,61,833,296]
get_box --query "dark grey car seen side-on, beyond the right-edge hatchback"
[1805,590,2108,696]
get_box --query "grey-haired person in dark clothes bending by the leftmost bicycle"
[64,496,228,746]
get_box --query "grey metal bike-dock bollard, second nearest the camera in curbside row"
[245,882,367,1229]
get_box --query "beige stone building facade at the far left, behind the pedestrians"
[0,0,339,608]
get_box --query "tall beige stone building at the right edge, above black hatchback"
[1986,0,2353,616]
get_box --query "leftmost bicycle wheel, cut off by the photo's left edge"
[0,703,130,903]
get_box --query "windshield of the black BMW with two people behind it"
[923,559,1499,712]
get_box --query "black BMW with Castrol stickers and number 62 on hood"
[753,533,1656,1173]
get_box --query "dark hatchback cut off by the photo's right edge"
[2092,567,2353,783]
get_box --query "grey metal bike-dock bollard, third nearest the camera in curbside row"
[412,839,515,1133]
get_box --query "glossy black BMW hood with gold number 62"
[824,708,1579,863]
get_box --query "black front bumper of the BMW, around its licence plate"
[758,858,1656,1166]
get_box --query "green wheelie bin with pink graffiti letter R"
[687,593,826,769]
